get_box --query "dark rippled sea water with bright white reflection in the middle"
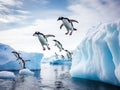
[0,63,120,90]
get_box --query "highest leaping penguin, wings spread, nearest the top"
[57,17,79,35]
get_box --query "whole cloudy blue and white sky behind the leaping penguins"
[0,0,120,57]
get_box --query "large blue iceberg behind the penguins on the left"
[0,43,43,70]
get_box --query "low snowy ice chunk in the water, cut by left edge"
[0,71,15,79]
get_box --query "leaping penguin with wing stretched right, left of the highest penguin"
[33,32,55,50]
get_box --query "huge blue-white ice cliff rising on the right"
[70,20,120,86]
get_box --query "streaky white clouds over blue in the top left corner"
[0,0,29,27]
